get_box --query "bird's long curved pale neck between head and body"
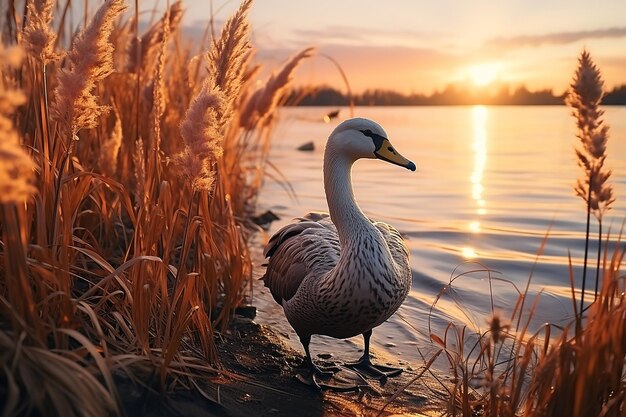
[324,146,373,247]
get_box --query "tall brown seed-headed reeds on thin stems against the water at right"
[566,50,615,308]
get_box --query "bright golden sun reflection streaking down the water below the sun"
[462,106,488,259]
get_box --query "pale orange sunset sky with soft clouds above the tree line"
[166,0,626,93]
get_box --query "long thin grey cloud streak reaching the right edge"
[487,27,626,49]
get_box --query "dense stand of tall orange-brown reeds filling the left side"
[0,0,310,416]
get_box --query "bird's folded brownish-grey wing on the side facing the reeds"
[262,212,340,304]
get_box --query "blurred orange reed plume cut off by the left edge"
[0,45,36,204]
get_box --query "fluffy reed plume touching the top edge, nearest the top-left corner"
[22,0,60,65]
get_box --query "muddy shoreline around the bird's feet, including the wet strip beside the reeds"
[117,232,446,417]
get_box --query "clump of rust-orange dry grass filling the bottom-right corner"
[525,241,626,417]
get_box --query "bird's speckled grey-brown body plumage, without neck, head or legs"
[263,212,411,338]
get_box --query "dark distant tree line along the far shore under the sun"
[287,84,626,106]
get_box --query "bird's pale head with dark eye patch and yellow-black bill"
[327,118,415,171]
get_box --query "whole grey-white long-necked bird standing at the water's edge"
[262,118,415,387]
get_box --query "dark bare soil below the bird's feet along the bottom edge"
[119,318,442,417]
